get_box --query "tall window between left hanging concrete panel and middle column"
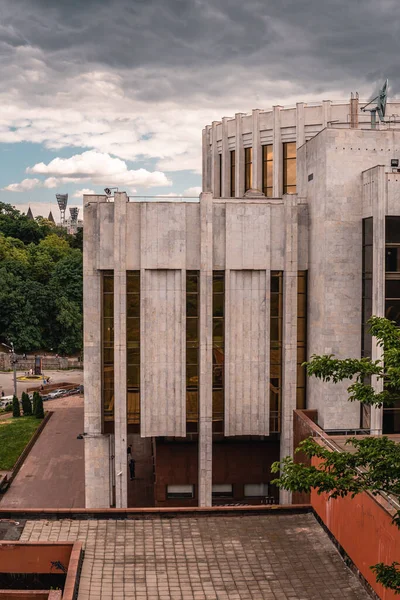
[186,271,200,433]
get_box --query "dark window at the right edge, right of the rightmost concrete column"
[383,217,400,433]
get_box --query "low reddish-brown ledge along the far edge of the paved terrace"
[0,504,313,521]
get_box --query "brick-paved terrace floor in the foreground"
[21,514,370,600]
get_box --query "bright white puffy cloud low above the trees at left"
[26,150,172,190]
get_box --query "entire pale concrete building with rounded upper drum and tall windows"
[84,100,400,507]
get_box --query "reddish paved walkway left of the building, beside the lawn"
[0,396,85,508]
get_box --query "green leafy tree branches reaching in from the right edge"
[272,317,400,594]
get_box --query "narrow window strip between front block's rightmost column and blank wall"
[296,271,307,408]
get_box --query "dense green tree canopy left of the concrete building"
[0,202,83,354]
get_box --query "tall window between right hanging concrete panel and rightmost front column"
[269,271,283,433]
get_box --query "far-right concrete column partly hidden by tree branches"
[371,166,387,435]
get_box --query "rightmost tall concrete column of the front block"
[280,195,298,504]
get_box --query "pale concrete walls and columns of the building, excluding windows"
[84,102,400,507]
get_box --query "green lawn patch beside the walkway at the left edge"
[0,417,42,471]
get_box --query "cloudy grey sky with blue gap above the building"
[0,0,400,215]
